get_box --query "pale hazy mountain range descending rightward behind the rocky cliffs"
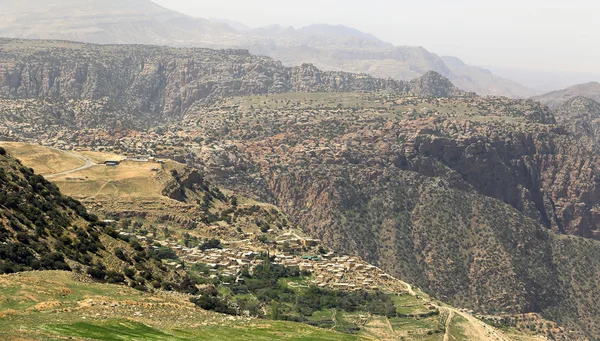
[0,0,537,97]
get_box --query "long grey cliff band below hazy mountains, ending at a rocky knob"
[0,39,465,128]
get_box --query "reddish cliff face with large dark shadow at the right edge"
[409,123,600,239]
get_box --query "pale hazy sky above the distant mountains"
[155,0,600,74]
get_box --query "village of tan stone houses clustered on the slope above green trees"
[119,226,407,293]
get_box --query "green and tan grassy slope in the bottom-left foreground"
[0,271,364,341]
